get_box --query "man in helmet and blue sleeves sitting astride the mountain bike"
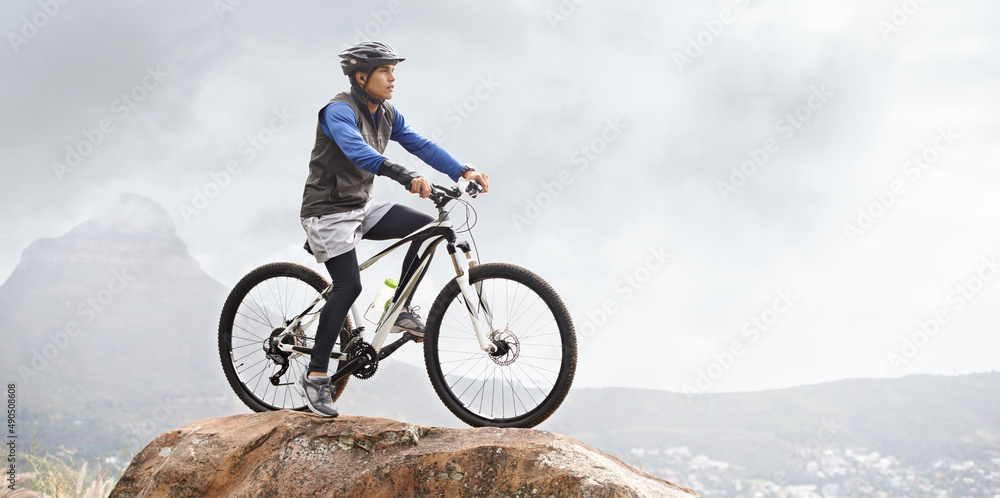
[299,42,489,417]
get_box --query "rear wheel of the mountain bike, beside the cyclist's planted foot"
[219,263,351,412]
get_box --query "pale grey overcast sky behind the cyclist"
[0,0,1000,392]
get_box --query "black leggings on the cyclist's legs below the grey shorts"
[309,204,434,374]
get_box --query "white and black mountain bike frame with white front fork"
[274,194,497,360]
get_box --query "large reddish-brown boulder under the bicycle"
[111,411,695,497]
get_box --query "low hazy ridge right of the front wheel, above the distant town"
[544,373,1000,476]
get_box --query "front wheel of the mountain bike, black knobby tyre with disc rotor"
[424,263,576,428]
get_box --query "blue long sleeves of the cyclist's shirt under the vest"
[319,102,462,182]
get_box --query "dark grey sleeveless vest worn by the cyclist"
[299,88,396,218]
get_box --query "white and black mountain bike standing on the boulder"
[219,181,576,428]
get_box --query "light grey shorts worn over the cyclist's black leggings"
[302,200,392,263]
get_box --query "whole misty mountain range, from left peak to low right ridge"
[0,194,1000,486]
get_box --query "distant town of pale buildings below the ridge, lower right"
[628,446,1000,498]
